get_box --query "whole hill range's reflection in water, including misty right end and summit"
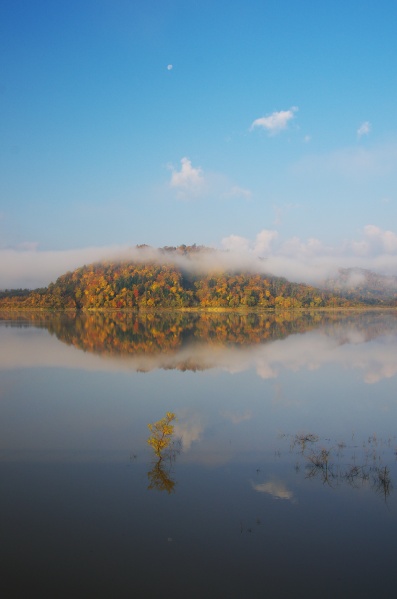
[0,311,397,370]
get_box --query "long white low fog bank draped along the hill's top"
[0,225,397,289]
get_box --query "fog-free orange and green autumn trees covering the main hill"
[0,255,359,310]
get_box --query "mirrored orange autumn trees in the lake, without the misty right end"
[0,312,337,358]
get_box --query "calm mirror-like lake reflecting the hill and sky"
[0,311,397,598]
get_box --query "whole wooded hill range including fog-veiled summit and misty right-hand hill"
[0,245,397,310]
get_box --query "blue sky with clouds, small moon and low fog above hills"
[0,0,397,289]
